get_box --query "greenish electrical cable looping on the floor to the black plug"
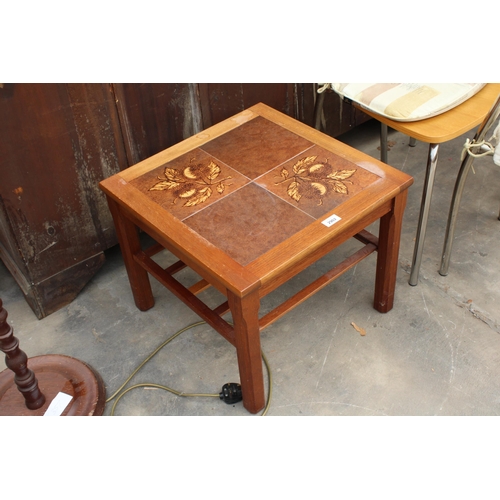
[106,321,272,417]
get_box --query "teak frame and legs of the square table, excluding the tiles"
[101,104,413,413]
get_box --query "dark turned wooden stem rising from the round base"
[0,299,45,410]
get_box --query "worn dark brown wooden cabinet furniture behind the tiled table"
[0,83,366,318]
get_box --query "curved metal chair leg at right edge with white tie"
[439,96,500,276]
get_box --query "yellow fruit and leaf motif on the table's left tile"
[149,160,231,207]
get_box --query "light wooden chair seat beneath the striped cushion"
[363,83,500,144]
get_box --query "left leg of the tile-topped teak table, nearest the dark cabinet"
[108,198,154,311]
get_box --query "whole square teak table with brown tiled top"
[100,104,413,413]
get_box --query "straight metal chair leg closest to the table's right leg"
[408,144,439,286]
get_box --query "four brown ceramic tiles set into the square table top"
[130,116,380,266]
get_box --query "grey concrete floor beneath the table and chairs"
[0,122,500,416]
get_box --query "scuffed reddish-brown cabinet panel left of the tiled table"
[0,84,127,318]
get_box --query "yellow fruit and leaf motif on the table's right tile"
[276,156,356,205]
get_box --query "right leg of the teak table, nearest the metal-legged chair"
[374,190,408,313]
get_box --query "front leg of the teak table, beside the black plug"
[227,290,265,413]
